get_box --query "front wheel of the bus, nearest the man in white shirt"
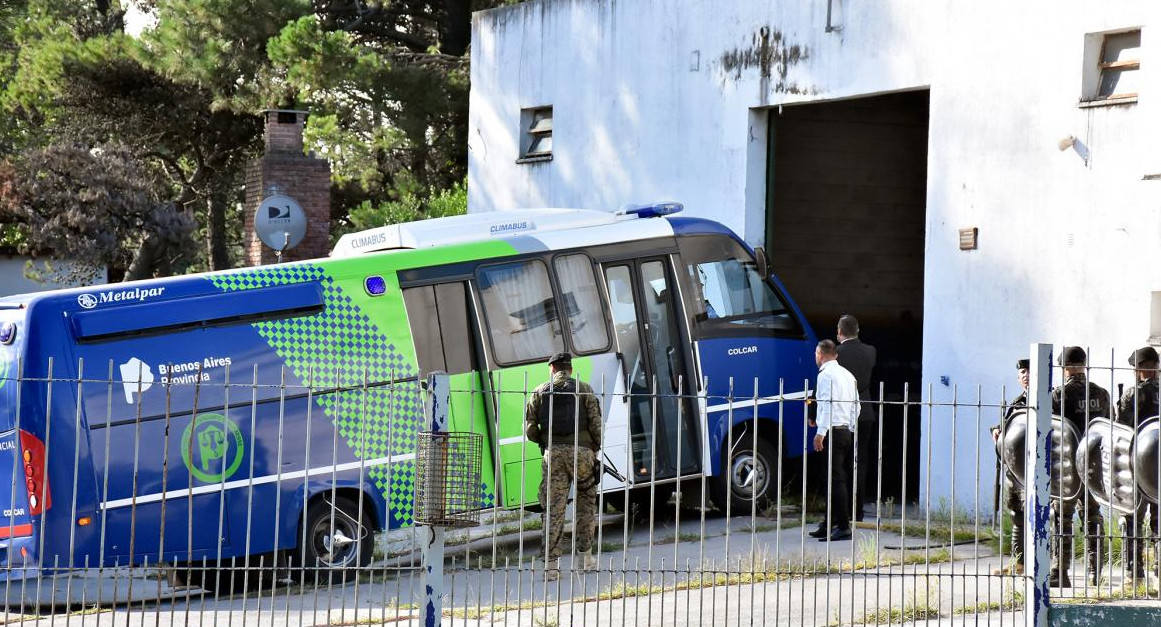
[709,437,778,516]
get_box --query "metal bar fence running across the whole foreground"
[0,347,1161,626]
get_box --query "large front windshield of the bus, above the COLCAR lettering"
[678,236,802,334]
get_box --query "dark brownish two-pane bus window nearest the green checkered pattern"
[403,281,473,374]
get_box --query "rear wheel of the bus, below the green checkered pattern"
[291,497,375,582]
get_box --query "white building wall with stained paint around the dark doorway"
[468,0,1161,505]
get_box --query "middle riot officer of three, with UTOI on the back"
[1050,346,1112,588]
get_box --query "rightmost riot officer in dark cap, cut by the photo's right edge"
[1117,346,1159,579]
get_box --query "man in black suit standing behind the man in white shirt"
[838,314,879,520]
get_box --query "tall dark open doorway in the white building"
[766,91,930,503]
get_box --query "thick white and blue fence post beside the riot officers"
[1023,344,1052,627]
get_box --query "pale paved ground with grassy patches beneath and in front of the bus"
[6,516,1151,627]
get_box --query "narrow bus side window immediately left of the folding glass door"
[553,254,608,354]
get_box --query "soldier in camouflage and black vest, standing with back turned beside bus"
[524,353,601,579]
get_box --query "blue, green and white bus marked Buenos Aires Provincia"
[0,203,816,599]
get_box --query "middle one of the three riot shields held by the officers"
[1076,418,1141,513]
